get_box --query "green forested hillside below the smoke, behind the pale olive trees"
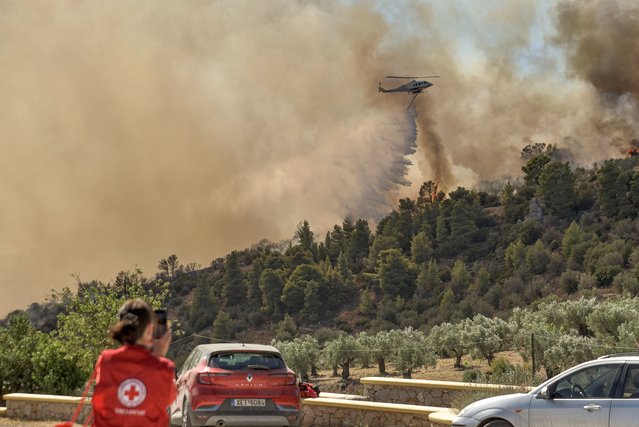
[0,144,639,392]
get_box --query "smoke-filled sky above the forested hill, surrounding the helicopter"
[0,0,639,315]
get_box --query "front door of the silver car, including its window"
[528,363,622,427]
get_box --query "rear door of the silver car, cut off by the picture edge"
[610,363,639,427]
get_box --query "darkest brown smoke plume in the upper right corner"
[555,0,639,152]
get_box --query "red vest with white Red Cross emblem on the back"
[92,345,176,427]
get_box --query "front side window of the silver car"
[554,364,620,399]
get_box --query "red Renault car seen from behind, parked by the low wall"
[170,343,301,427]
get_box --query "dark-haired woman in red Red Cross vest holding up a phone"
[92,299,176,427]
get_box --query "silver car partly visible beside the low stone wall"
[452,353,639,427]
